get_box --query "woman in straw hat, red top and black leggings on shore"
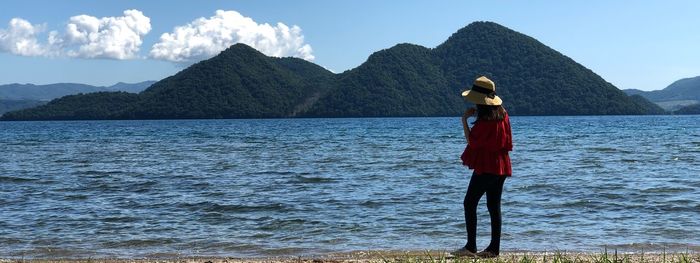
[452,76,513,258]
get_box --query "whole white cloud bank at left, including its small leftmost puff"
[0,10,151,59]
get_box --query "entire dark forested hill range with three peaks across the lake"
[3,22,664,120]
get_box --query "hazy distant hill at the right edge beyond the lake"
[624,76,700,111]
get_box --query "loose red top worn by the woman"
[462,114,513,176]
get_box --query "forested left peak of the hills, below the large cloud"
[127,44,332,119]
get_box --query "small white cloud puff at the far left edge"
[0,18,47,56]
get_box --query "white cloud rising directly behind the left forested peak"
[150,10,314,63]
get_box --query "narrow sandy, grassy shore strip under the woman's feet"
[0,251,700,263]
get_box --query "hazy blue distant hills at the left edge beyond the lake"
[0,81,155,101]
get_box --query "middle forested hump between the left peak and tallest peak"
[305,44,454,117]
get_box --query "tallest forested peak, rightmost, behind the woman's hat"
[434,22,661,115]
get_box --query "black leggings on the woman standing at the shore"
[464,173,506,255]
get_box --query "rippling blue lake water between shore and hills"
[0,116,700,258]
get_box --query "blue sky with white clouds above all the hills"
[0,0,700,90]
